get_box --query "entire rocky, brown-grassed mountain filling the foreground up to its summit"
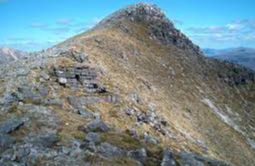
[0,3,255,166]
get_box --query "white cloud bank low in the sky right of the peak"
[187,19,255,47]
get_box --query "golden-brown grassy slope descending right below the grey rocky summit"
[51,19,255,165]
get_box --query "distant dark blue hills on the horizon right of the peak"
[203,47,255,70]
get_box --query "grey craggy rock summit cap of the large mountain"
[96,3,202,55]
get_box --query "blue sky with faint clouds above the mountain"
[0,0,255,51]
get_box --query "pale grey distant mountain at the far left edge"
[0,47,28,64]
